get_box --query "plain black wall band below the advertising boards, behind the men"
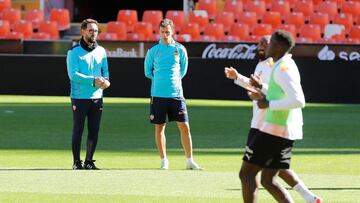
[0,54,360,103]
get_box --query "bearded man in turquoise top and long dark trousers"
[66,19,110,170]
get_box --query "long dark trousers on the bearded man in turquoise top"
[71,99,103,161]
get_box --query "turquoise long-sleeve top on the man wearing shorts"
[144,40,188,98]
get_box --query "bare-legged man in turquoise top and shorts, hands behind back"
[144,19,202,170]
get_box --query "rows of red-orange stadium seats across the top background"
[0,0,360,43]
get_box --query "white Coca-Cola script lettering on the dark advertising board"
[202,44,257,60]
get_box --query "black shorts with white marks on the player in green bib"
[243,131,294,169]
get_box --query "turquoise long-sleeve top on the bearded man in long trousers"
[66,42,109,99]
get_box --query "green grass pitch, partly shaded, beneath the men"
[0,95,360,203]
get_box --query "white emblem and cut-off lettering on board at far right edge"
[318,45,360,61]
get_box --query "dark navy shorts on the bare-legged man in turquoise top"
[150,97,189,124]
